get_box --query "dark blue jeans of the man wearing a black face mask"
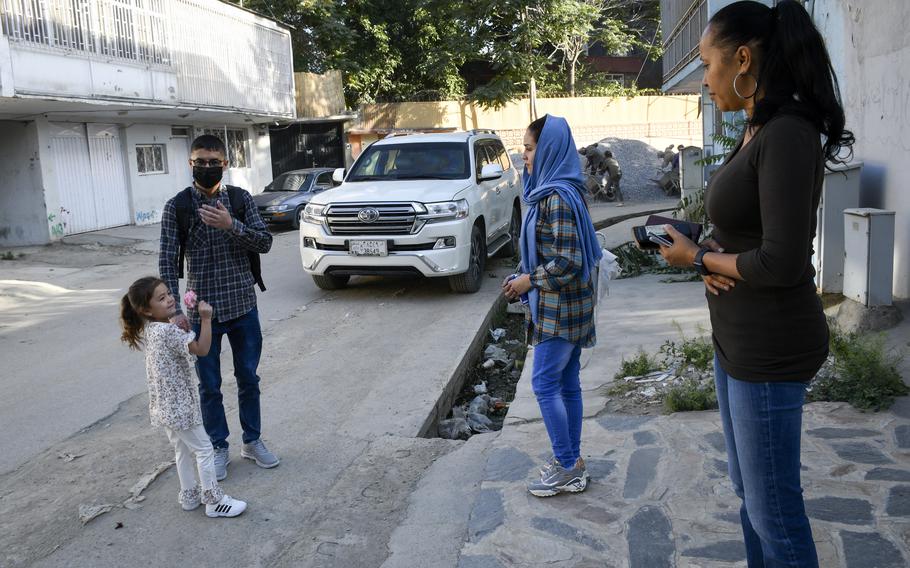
[193,308,262,448]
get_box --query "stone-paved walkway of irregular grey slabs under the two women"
[459,403,910,568]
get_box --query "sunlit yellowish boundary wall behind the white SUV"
[362,95,702,153]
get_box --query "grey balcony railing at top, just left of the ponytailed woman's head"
[660,0,708,83]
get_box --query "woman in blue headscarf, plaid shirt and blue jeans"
[503,115,602,497]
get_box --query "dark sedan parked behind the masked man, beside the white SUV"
[253,168,335,229]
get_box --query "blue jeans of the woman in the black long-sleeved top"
[714,357,818,568]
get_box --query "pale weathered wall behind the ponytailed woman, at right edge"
[809,0,910,298]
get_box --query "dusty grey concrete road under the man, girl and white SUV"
[0,223,509,566]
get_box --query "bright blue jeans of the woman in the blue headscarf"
[531,337,583,468]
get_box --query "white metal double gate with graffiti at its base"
[50,123,131,235]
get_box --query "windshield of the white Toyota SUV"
[346,142,471,182]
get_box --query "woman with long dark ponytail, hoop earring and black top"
[661,0,853,567]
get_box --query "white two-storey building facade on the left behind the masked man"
[0,0,295,246]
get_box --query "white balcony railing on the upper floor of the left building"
[0,0,171,66]
